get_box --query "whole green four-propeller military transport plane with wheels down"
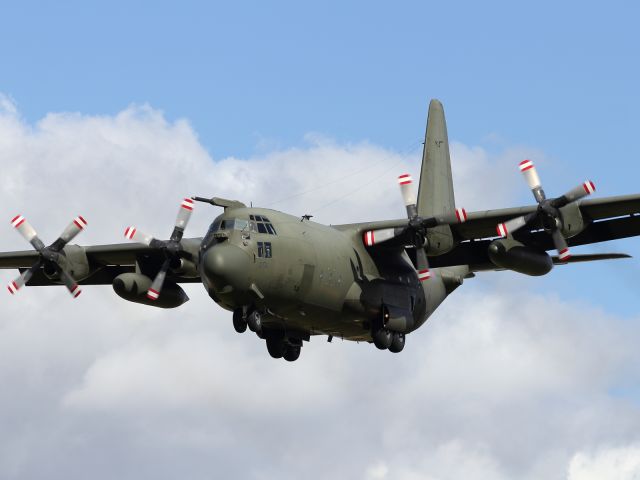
[0,100,640,361]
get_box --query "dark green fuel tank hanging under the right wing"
[489,238,553,277]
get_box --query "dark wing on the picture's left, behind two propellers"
[0,238,202,286]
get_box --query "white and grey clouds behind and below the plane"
[0,99,640,480]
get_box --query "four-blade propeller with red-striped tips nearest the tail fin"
[364,174,467,282]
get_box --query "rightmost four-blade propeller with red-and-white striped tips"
[496,160,596,262]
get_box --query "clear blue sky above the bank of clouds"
[0,1,639,179]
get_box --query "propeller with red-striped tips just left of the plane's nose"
[124,198,194,300]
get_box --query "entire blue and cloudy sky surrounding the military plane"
[0,1,640,480]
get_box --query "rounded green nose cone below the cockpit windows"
[202,242,249,292]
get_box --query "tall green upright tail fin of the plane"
[418,99,456,217]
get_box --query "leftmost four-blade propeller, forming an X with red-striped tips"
[7,215,87,298]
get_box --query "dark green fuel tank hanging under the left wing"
[113,273,189,308]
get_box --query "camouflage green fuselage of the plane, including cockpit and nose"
[200,208,456,341]
